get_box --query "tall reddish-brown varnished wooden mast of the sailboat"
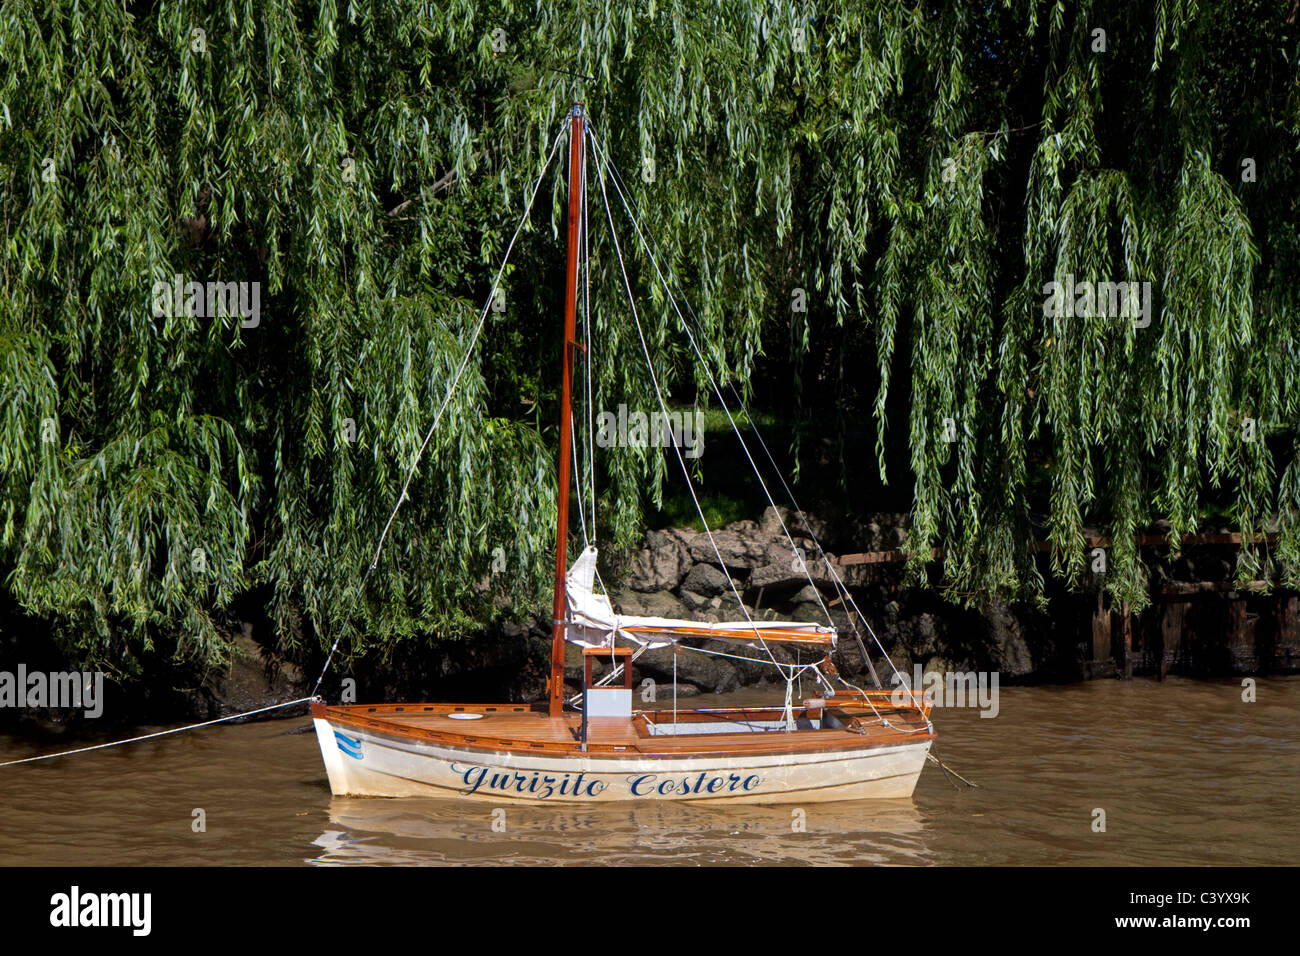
[547,103,585,717]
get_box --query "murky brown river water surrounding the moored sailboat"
[0,676,1300,866]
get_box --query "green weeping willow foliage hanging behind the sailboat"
[0,0,1300,671]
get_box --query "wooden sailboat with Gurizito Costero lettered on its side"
[311,103,935,804]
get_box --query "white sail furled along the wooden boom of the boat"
[564,546,836,648]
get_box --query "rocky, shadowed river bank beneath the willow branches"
[0,509,1300,732]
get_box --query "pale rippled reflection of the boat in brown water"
[307,797,935,866]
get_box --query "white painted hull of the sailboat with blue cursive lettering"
[313,717,931,804]
